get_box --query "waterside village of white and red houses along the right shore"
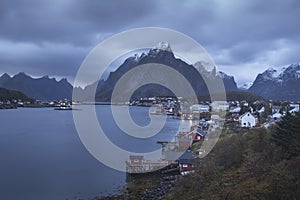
[126,97,299,175]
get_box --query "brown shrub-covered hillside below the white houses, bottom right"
[169,114,300,199]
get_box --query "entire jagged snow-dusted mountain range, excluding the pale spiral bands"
[0,43,300,101]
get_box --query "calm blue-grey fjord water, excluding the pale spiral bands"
[0,106,180,199]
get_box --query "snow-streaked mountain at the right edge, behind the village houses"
[249,63,300,101]
